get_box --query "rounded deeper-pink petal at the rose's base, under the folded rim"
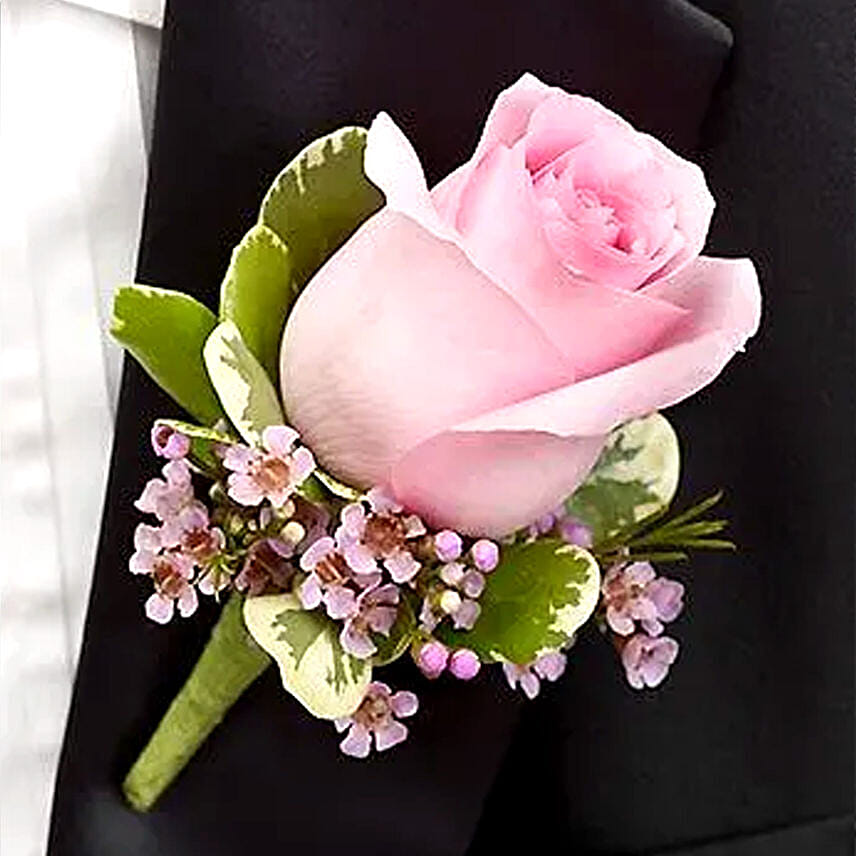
[392,431,604,536]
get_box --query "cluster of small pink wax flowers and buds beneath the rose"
[129,423,684,757]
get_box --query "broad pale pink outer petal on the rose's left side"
[281,210,573,488]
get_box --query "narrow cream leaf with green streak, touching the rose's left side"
[203,321,285,445]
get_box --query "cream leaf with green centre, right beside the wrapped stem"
[244,594,372,719]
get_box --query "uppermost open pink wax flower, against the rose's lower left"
[223,425,315,508]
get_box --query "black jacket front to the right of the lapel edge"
[473,0,856,856]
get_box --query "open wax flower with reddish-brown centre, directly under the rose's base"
[336,488,426,583]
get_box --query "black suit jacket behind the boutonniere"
[49,0,854,856]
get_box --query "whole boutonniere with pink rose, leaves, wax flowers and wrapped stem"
[113,75,760,810]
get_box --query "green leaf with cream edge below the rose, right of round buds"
[437,538,600,663]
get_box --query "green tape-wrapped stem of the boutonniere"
[122,595,270,811]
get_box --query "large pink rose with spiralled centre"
[282,74,761,535]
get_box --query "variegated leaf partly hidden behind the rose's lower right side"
[566,413,680,545]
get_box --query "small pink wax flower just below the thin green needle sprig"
[601,562,684,636]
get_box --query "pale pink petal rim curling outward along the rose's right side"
[456,257,761,437]
